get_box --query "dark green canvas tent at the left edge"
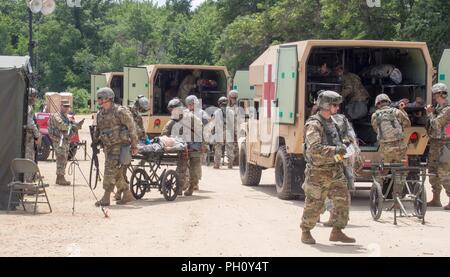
[0,59,29,209]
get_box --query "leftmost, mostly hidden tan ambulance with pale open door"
[90,72,124,112]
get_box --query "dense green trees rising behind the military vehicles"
[0,0,450,112]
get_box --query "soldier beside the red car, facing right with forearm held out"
[48,101,83,186]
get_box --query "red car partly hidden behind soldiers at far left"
[36,113,80,161]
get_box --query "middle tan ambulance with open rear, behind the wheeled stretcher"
[124,64,231,136]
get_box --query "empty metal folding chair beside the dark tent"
[8,159,52,214]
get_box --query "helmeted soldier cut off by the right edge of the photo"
[427,83,450,210]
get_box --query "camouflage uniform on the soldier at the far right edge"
[428,101,450,197]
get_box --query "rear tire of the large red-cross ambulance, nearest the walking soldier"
[275,146,305,200]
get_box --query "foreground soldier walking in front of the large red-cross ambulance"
[300,91,355,244]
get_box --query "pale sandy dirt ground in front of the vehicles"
[0,115,450,256]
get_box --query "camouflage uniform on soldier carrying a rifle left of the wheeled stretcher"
[95,104,138,193]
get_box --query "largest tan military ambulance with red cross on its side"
[239,40,433,199]
